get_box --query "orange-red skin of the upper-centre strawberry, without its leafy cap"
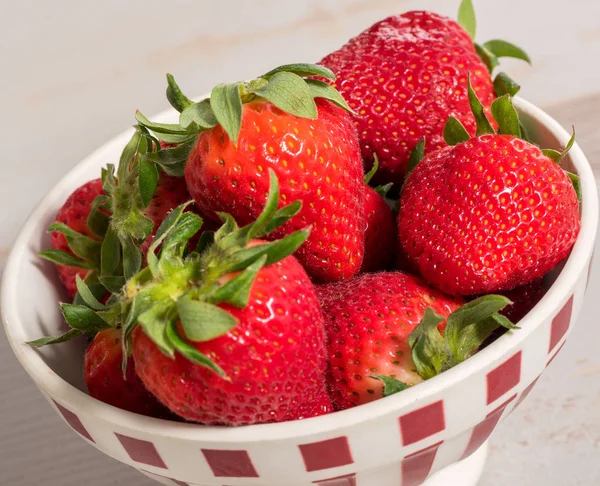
[185,100,365,282]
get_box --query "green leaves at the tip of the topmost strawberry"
[457,0,531,96]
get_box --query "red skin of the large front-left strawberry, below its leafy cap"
[133,257,332,426]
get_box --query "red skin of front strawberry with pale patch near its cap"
[317,272,463,410]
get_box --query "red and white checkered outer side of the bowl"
[48,266,588,486]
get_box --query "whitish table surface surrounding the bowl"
[0,0,600,486]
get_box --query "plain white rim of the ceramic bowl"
[0,96,598,444]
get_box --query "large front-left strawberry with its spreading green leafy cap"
[31,170,332,425]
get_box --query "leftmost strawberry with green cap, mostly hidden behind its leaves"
[40,130,206,297]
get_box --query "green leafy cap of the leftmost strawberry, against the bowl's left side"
[39,126,172,299]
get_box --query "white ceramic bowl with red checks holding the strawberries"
[1,98,598,486]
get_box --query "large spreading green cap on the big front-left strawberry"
[33,170,310,376]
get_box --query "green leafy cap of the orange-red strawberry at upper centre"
[136,64,352,154]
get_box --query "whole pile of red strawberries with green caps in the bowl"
[30,0,580,425]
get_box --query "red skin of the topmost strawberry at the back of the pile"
[321,11,495,184]
